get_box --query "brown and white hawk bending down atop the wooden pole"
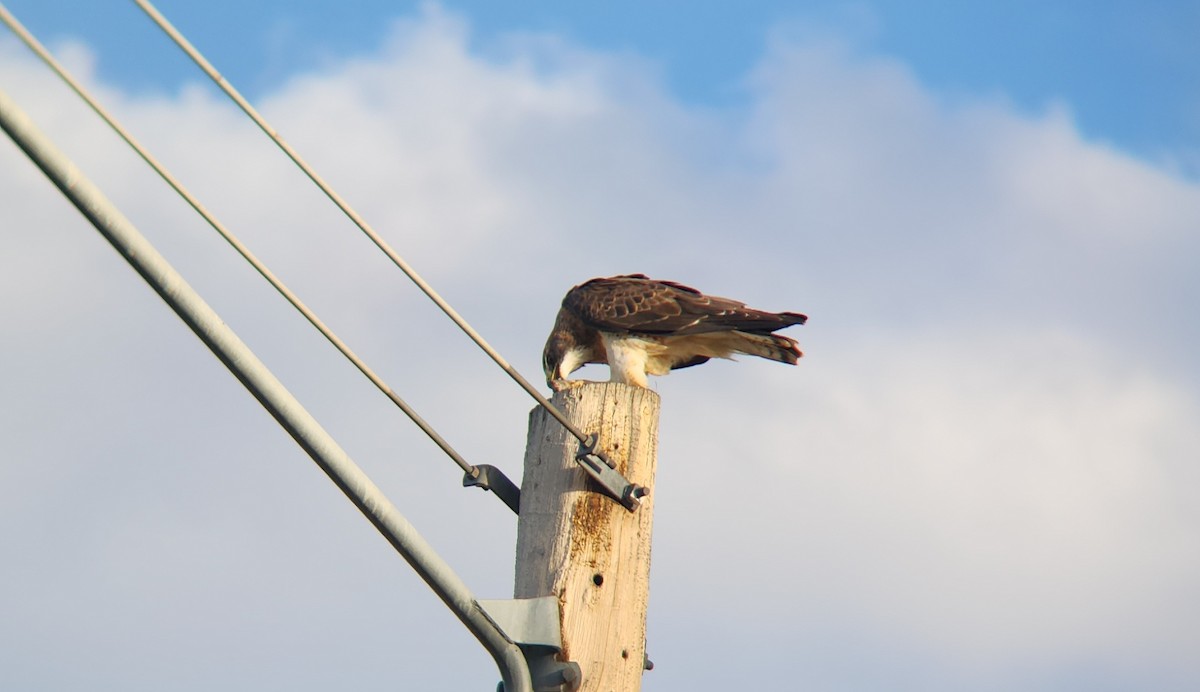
[542,273,808,391]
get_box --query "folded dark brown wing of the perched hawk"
[563,273,808,335]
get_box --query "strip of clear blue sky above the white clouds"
[8,0,1200,175]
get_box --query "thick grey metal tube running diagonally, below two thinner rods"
[0,90,533,692]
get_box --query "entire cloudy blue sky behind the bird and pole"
[0,0,1200,691]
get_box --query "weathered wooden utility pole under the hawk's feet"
[514,383,659,692]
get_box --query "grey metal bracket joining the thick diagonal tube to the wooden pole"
[476,596,583,692]
